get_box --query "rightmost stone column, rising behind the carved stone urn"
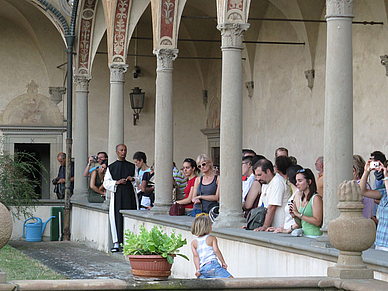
[320,0,353,245]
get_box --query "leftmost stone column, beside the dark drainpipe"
[72,75,91,200]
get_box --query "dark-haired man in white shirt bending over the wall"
[253,159,291,231]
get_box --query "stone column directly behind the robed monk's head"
[108,64,128,163]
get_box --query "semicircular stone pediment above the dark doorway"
[0,81,63,126]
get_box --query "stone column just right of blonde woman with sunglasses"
[214,23,249,227]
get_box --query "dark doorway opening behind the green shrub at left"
[14,143,50,199]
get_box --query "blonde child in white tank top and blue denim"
[191,214,233,279]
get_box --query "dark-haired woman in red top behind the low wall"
[176,158,199,212]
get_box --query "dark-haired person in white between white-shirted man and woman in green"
[266,165,303,233]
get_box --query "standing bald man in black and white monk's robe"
[103,144,136,253]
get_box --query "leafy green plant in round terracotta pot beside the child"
[123,225,189,279]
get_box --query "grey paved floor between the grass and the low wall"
[9,241,133,280]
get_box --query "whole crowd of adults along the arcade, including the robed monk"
[53,144,388,251]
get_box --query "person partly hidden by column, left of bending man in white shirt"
[242,156,261,218]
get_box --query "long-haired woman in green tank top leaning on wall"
[290,169,323,238]
